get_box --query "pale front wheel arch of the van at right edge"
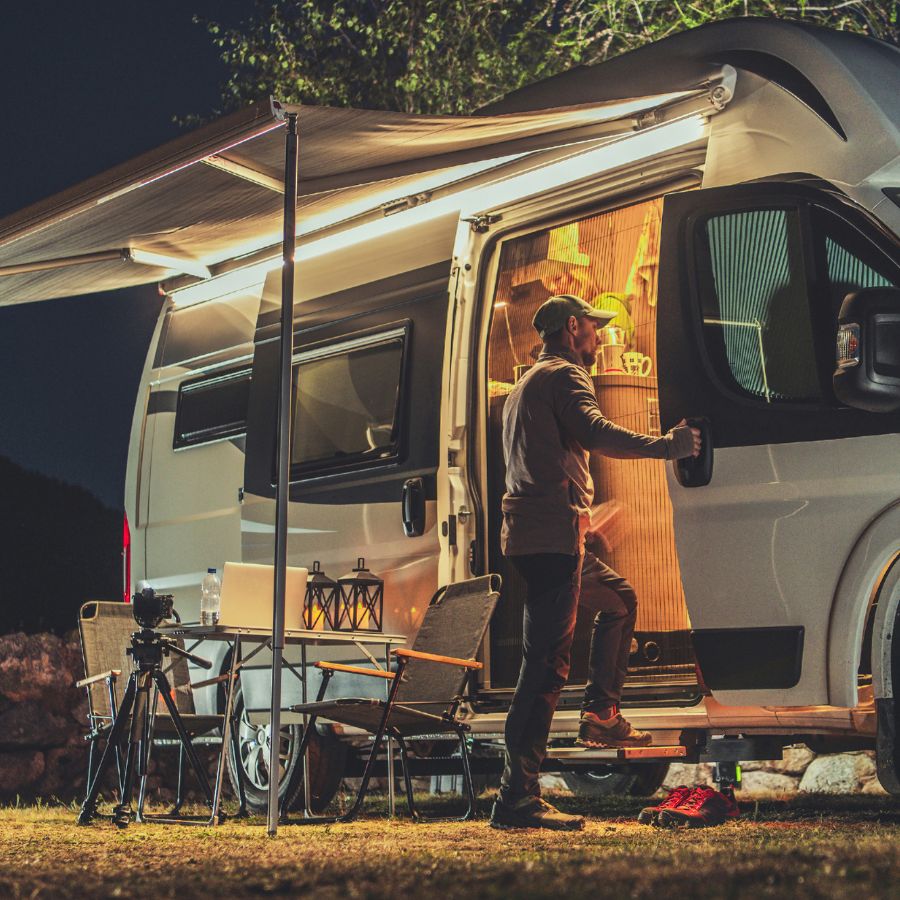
[827,502,900,707]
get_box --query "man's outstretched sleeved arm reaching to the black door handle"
[551,366,699,459]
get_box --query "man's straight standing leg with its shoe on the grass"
[492,553,583,827]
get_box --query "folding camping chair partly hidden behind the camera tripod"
[76,601,234,820]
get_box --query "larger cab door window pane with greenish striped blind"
[699,209,822,403]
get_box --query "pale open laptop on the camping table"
[219,562,309,631]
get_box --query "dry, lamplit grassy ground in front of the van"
[0,796,900,900]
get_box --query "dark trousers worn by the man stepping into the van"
[500,553,637,804]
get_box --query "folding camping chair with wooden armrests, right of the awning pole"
[291,575,500,825]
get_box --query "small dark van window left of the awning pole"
[173,368,250,450]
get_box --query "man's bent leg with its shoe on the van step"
[579,554,651,746]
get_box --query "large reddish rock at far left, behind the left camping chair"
[0,632,83,713]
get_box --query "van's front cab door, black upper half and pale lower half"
[657,184,900,706]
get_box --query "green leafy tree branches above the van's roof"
[203,0,900,114]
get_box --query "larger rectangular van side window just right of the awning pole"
[291,327,408,475]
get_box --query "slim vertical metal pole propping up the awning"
[268,113,298,837]
